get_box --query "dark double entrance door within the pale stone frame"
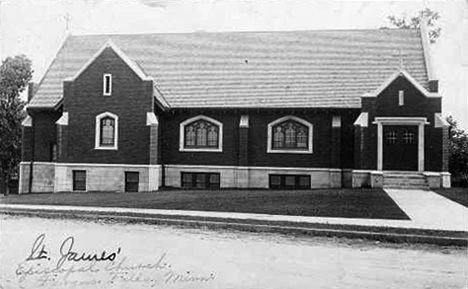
[382,125,418,171]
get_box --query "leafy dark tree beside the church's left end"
[0,55,32,194]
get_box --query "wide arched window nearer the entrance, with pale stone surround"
[268,116,312,153]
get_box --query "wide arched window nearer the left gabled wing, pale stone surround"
[179,116,222,151]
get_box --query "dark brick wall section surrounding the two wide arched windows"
[160,110,358,168]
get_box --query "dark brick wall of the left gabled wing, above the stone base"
[60,48,153,164]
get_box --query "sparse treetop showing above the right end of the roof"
[383,8,441,43]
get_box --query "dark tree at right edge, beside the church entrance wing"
[446,116,468,187]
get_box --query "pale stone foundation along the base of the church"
[19,162,450,194]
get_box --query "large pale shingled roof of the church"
[29,29,428,108]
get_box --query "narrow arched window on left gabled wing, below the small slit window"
[95,112,118,149]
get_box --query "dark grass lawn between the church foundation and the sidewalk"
[0,189,409,220]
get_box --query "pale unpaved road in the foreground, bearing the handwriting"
[0,215,467,289]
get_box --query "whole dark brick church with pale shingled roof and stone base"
[20,27,450,193]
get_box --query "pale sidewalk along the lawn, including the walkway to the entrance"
[0,189,468,232]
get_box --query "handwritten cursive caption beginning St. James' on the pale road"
[15,234,215,288]
